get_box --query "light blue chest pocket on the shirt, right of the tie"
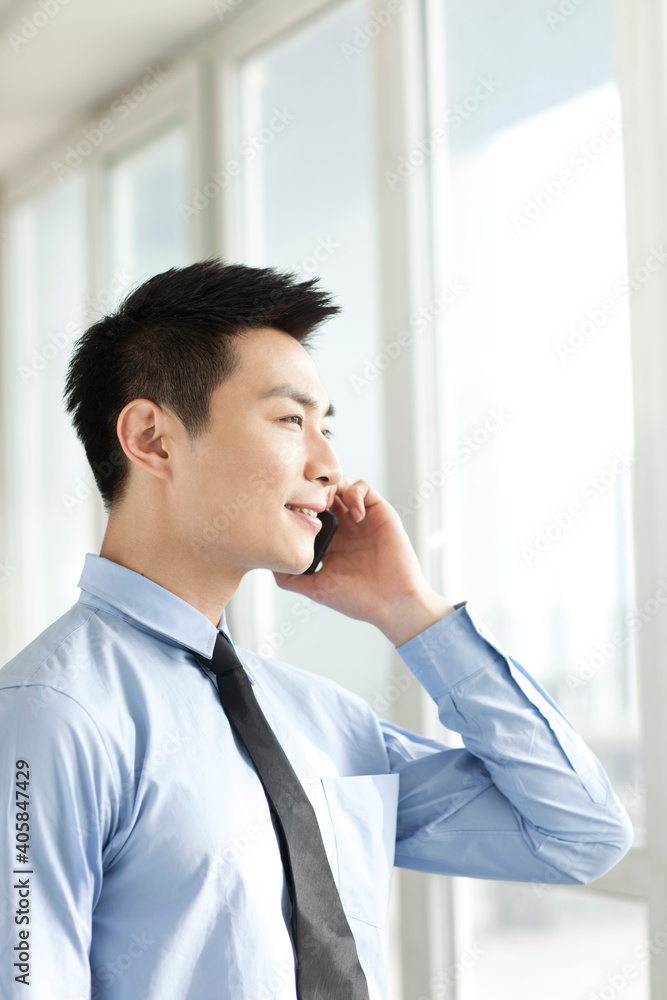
[320,774,399,927]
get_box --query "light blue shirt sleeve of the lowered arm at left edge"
[0,684,117,1000]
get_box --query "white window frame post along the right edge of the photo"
[614,0,667,1000]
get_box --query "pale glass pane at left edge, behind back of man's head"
[1,176,97,663]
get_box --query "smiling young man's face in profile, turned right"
[174,328,343,573]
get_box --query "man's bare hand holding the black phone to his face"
[273,476,454,645]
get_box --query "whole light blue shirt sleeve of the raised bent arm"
[380,601,633,884]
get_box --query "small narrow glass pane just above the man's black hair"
[107,126,190,297]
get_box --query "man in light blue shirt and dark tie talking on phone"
[0,261,632,1000]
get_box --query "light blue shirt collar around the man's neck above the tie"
[77,552,233,659]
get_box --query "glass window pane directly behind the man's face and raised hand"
[239,3,387,711]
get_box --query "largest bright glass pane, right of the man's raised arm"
[437,0,644,834]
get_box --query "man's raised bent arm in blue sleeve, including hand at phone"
[274,477,632,883]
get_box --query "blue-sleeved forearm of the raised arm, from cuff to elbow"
[398,607,632,880]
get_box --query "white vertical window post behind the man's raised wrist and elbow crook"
[372,2,457,1000]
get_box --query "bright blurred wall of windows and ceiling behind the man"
[0,0,667,1000]
